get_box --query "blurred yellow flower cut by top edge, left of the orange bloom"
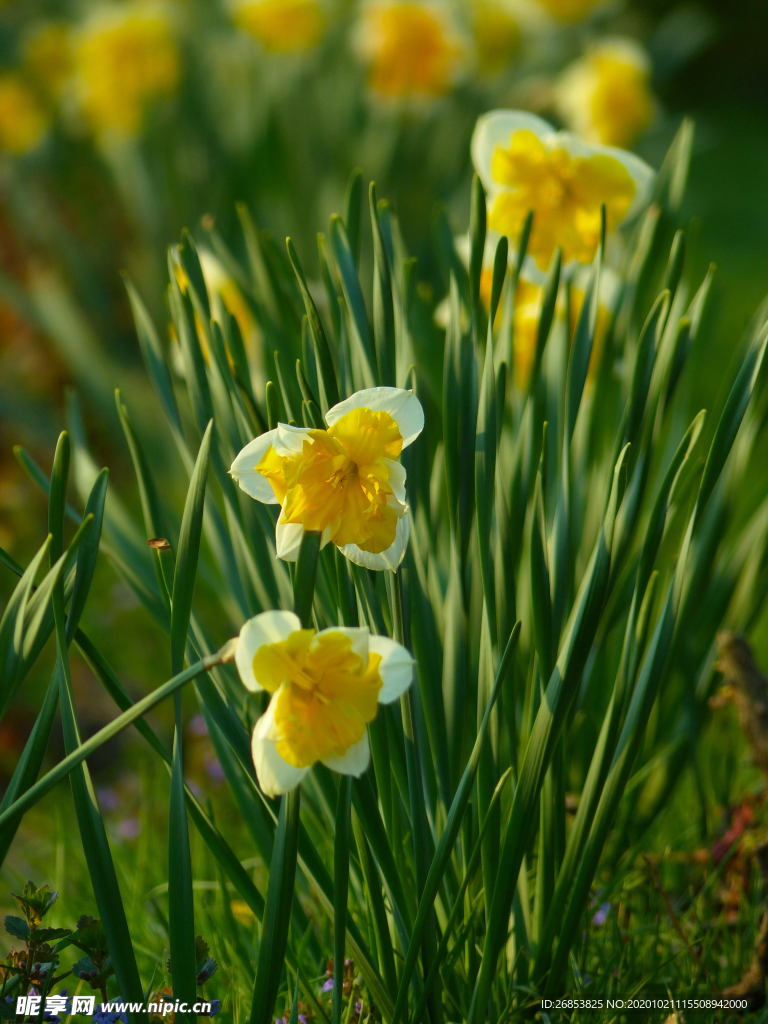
[234,0,326,53]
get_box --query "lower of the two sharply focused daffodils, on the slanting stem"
[234,611,414,797]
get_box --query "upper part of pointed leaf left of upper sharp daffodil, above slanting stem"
[171,420,213,674]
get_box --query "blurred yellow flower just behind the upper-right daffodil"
[555,39,654,147]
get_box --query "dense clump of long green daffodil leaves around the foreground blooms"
[0,119,768,1024]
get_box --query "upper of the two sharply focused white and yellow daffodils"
[229,387,424,570]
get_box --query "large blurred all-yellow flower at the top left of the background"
[75,2,180,135]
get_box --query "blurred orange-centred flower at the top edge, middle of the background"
[356,0,467,99]
